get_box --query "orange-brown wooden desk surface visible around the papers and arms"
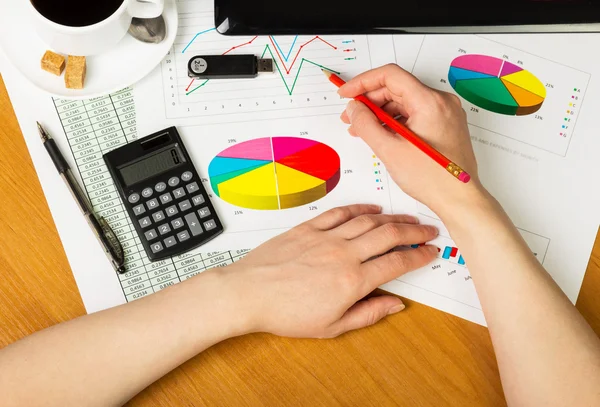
[0,77,600,407]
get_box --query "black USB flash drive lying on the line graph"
[188,54,274,79]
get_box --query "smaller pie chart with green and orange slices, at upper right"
[448,54,546,116]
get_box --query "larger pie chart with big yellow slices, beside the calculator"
[208,137,340,210]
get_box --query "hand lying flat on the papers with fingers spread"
[219,205,437,338]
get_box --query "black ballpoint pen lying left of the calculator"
[37,122,126,273]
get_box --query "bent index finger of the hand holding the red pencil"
[338,64,429,106]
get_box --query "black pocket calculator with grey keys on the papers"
[104,127,223,261]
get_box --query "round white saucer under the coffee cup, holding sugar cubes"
[0,0,178,99]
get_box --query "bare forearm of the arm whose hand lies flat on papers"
[0,269,247,406]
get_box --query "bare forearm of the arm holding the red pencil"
[441,190,600,406]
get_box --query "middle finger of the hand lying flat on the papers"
[351,223,438,261]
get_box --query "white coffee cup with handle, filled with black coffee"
[25,0,164,56]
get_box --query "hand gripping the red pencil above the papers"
[339,64,480,214]
